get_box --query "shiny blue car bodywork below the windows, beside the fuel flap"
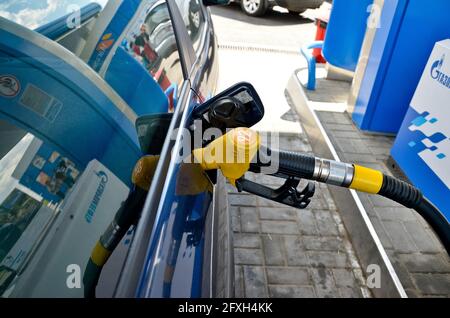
[137,0,221,297]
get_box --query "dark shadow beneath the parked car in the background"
[211,4,313,27]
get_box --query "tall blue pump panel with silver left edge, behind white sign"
[353,0,450,134]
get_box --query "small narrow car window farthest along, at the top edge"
[175,0,206,56]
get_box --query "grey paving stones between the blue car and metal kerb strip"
[227,111,370,298]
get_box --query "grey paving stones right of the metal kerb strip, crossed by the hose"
[316,111,450,297]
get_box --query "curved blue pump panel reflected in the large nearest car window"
[0,18,141,185]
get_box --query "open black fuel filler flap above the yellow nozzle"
[192,82,264,133]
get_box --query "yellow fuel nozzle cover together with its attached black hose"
[193,128,450,255]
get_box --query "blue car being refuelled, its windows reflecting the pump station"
[0,0,227,297]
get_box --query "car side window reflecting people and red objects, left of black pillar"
[122,1,184,112]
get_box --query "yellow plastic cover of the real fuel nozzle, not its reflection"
[193,128,261,185]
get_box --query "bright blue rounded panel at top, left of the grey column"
[323,0,373,72]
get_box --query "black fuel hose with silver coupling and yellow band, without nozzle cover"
[250,147,450,255]
